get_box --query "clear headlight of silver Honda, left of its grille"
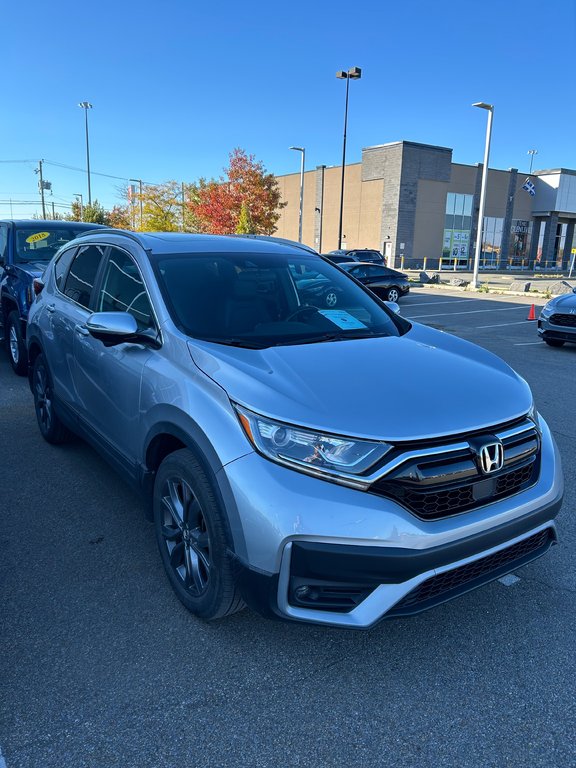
[233,403,392,488]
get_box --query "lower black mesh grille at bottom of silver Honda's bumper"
[388,528,555,616]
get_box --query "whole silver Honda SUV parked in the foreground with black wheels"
[28,230,563,627]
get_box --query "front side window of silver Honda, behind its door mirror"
[96,248,154,330]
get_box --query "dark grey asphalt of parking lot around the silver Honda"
[0,289,576,768]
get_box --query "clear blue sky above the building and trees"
[0,0,576,217]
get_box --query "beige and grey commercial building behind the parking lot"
[275,141,576,270]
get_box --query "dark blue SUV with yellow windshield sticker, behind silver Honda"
[0,219,101,376]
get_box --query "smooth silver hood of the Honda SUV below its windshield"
[189,324,532,442]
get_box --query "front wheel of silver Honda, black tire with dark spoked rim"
[154,449,244,621]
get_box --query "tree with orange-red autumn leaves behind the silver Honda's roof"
[187,148,286,235]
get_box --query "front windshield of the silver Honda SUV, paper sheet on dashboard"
[154,253,410,348]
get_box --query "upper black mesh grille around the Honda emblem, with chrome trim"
[370,422,540,520]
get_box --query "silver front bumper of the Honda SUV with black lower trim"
[223,422,563,628]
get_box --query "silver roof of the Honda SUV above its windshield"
[71,229,317,257]
